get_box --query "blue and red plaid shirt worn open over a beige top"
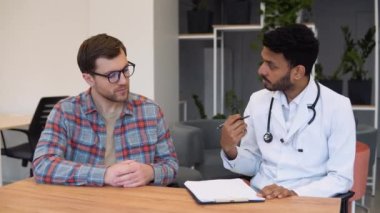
[33,90,178,186]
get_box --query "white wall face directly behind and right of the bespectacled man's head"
[89,0,156,98]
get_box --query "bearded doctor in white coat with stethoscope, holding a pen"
[220,24,356,199]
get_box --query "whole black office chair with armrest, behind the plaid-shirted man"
[0,96,67,176]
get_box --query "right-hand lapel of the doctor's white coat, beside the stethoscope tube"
[285,80,317,141]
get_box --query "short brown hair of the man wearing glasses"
[77,33,127,73]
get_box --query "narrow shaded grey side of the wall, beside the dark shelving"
[153,0,179,121]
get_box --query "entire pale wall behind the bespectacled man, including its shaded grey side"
[0,0,178,181]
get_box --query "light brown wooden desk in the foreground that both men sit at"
[0,178,340,213]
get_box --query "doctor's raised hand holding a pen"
[220,114,247,160]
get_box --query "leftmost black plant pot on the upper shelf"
[187,0,213,33]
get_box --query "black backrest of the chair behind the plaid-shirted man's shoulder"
[28,96,67,151]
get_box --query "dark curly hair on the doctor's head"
[263,24,319,76]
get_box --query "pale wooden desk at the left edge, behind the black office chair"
[0,114,32,186]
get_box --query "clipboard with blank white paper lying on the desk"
[185,178,265,204]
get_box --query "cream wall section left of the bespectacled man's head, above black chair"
[0,0,89,114]
